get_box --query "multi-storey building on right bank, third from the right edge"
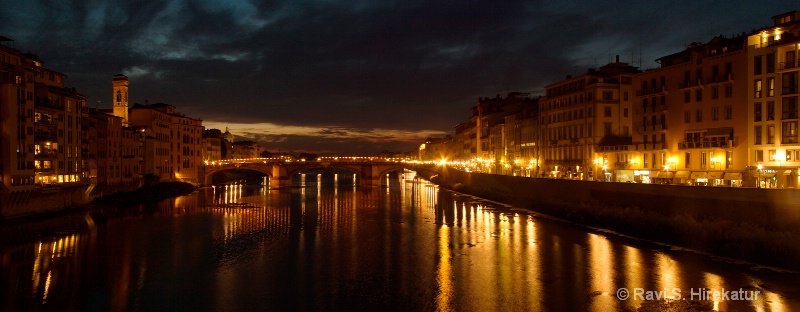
[539,57,639,181]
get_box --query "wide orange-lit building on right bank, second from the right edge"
[632,36,747,186]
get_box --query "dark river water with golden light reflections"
[0,173,800,311]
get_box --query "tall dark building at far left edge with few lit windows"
[0,37,86,192]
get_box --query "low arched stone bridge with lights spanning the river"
[199,157,411,188]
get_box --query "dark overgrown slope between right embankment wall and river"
[428,168,800,271]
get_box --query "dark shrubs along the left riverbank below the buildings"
[92,182,196,206]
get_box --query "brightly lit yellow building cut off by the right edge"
[743,11,800,188]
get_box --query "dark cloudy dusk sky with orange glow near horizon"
[0,0,800,155]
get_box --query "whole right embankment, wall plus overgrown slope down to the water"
[428,167,800,271]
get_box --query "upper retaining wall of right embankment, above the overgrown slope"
[434,168,800,228]
